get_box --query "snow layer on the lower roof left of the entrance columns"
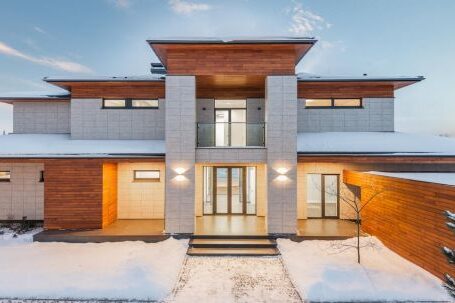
[0,134,165,158]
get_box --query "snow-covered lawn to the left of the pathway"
[0,232,187,300]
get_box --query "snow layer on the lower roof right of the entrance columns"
[297,132,455,156]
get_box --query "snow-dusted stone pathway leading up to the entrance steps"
[167,256,302,303]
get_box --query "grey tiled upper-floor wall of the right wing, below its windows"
[298,98,394,132]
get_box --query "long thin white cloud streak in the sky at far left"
[0,41,92,73]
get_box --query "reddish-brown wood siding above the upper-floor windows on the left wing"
[51,80,165,99]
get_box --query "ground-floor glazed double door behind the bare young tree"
[307,174,339,218]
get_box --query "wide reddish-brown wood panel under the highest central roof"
[161,44,300,75]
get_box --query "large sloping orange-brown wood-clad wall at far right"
[343,171,455,278]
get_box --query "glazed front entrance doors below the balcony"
[203,166,256,215]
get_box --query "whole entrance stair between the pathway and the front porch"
[187,235,280,256]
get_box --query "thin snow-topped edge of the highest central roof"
[147,36,316,44]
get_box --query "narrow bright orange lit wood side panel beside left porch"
[103,163,117,227]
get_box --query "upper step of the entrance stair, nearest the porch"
[189,239,276,248]
